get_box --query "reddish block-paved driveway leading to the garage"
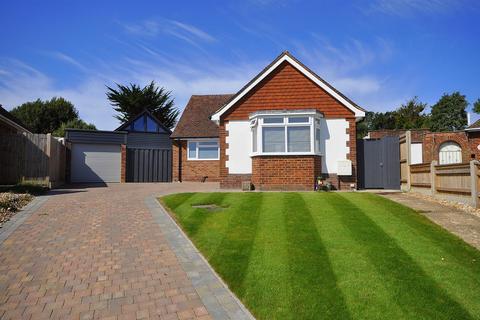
[0,183,221,319]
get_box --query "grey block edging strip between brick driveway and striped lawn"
[145,196,255,319]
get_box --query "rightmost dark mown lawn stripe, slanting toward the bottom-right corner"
[332,194,472,319]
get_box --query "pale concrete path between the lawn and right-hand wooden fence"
[379,192,480,249]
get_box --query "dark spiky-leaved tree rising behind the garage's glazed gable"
[107,81,179,129]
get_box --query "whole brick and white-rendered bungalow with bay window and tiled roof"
[171,52,365,190]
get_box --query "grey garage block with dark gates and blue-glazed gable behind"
[65,110,172,183]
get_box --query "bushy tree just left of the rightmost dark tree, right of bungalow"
[394,97,428,129]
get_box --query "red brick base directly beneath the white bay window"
[252,156,322,190]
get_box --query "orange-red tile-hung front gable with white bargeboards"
[212,52,365,121]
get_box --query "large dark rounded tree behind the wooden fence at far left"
[11,97,78,133]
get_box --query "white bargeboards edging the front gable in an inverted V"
[211,51,365,121]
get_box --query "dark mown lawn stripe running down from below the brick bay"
[283,193,351,319]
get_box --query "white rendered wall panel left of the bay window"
[225,121,252,174]
